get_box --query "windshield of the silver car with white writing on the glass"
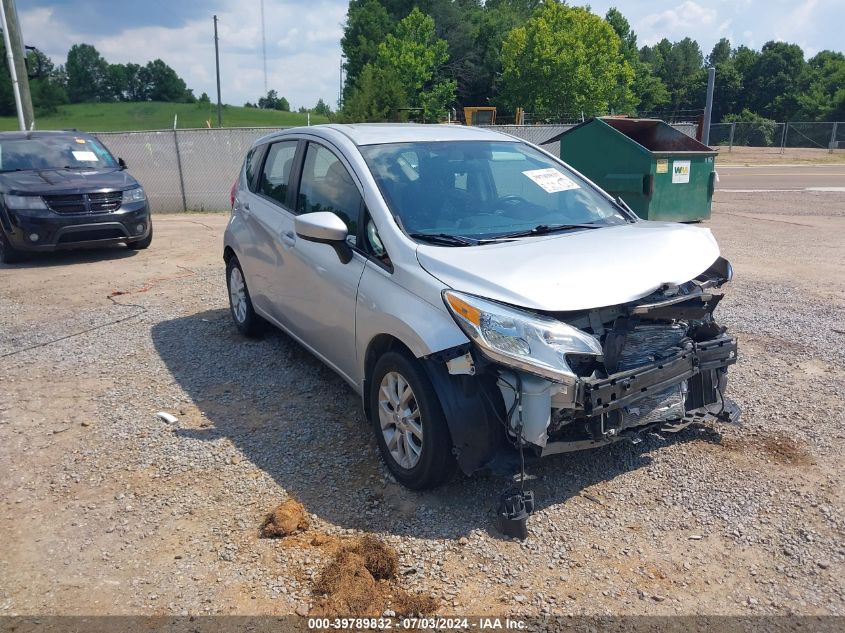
[361,141,626,243]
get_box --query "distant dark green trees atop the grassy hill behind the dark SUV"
[0,43,195,116]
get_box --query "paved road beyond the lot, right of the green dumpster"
[716,163,845,193]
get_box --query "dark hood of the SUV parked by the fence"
[0,168,138,195]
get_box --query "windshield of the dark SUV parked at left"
[0,135,117,171]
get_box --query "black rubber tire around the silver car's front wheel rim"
[367,351,458,490]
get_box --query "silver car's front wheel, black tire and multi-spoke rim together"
[369,352,457,490]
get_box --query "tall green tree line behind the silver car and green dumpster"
[340,0,845,121]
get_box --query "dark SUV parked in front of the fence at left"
[0,132,153,264]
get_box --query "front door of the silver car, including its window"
[273,142,366,383]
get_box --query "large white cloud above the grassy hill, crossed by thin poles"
[20,0,346,107]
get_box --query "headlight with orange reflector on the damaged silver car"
[443,290,602,384]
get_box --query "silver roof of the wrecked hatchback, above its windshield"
[274,123,518,146]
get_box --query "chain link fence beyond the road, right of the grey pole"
[710,121,845,152]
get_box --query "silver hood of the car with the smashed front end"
[417,221,719,312]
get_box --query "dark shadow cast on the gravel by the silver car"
[152,310,720,539]
